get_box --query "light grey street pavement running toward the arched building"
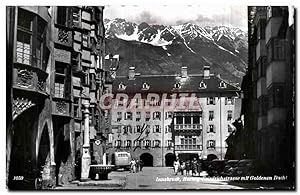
[55,167,249,190]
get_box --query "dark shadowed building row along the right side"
[227,6,296,181]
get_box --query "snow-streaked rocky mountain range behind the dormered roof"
[104,18,248,82]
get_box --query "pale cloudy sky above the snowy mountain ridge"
[104,5,247,30]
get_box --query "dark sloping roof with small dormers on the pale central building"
[112,74,240,94]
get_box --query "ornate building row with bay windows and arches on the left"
[7,6,105,189]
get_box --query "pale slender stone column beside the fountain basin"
[81,103,91,181]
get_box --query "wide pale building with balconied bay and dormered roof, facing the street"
[109,66,239,166]
